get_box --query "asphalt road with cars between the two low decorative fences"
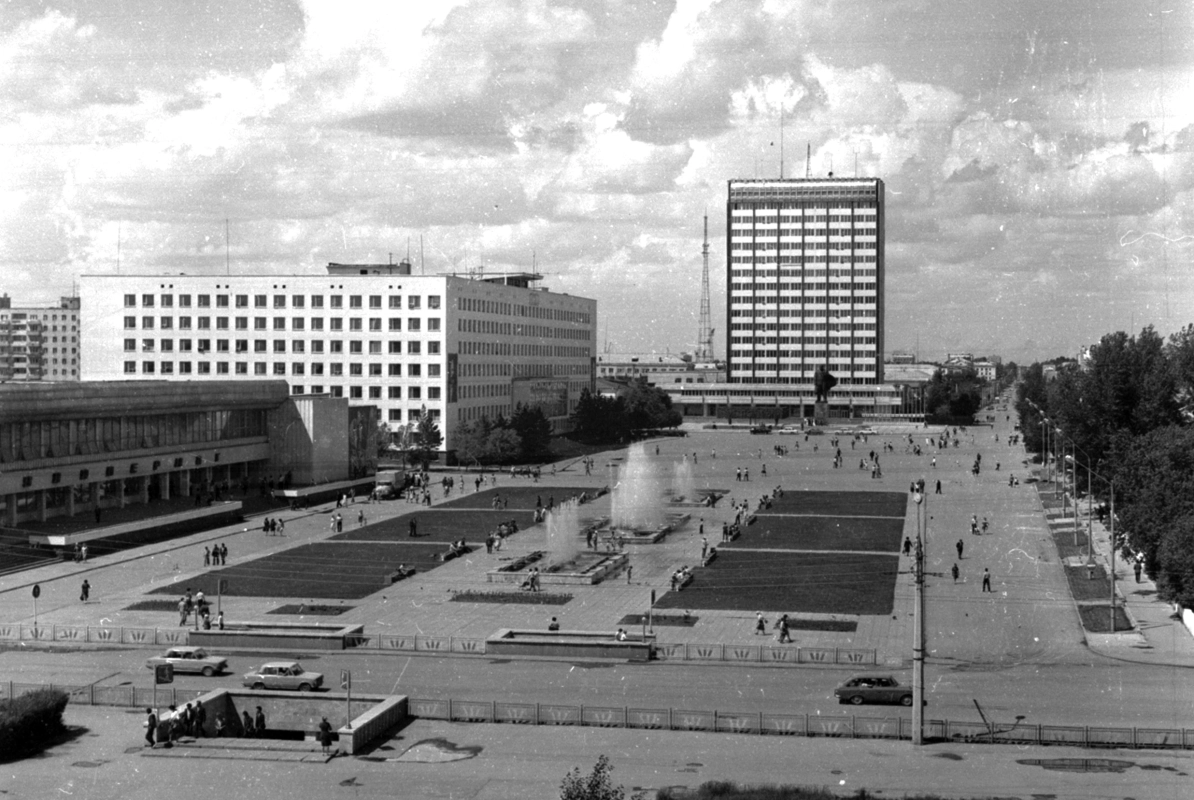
[0,648,1194,727]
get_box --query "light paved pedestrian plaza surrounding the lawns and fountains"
[0,410,1194,666]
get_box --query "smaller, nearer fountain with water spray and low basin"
[487,501,629,585]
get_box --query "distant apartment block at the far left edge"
[0,295,80,383]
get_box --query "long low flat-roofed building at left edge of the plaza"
[0,381,377,527]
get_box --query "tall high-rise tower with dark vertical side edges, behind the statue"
[726,178,884,390]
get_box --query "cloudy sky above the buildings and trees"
[0,0,1194,362]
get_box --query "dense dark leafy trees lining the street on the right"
[1016,326,1194,608]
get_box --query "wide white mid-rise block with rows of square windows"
[80,263,597,458]
